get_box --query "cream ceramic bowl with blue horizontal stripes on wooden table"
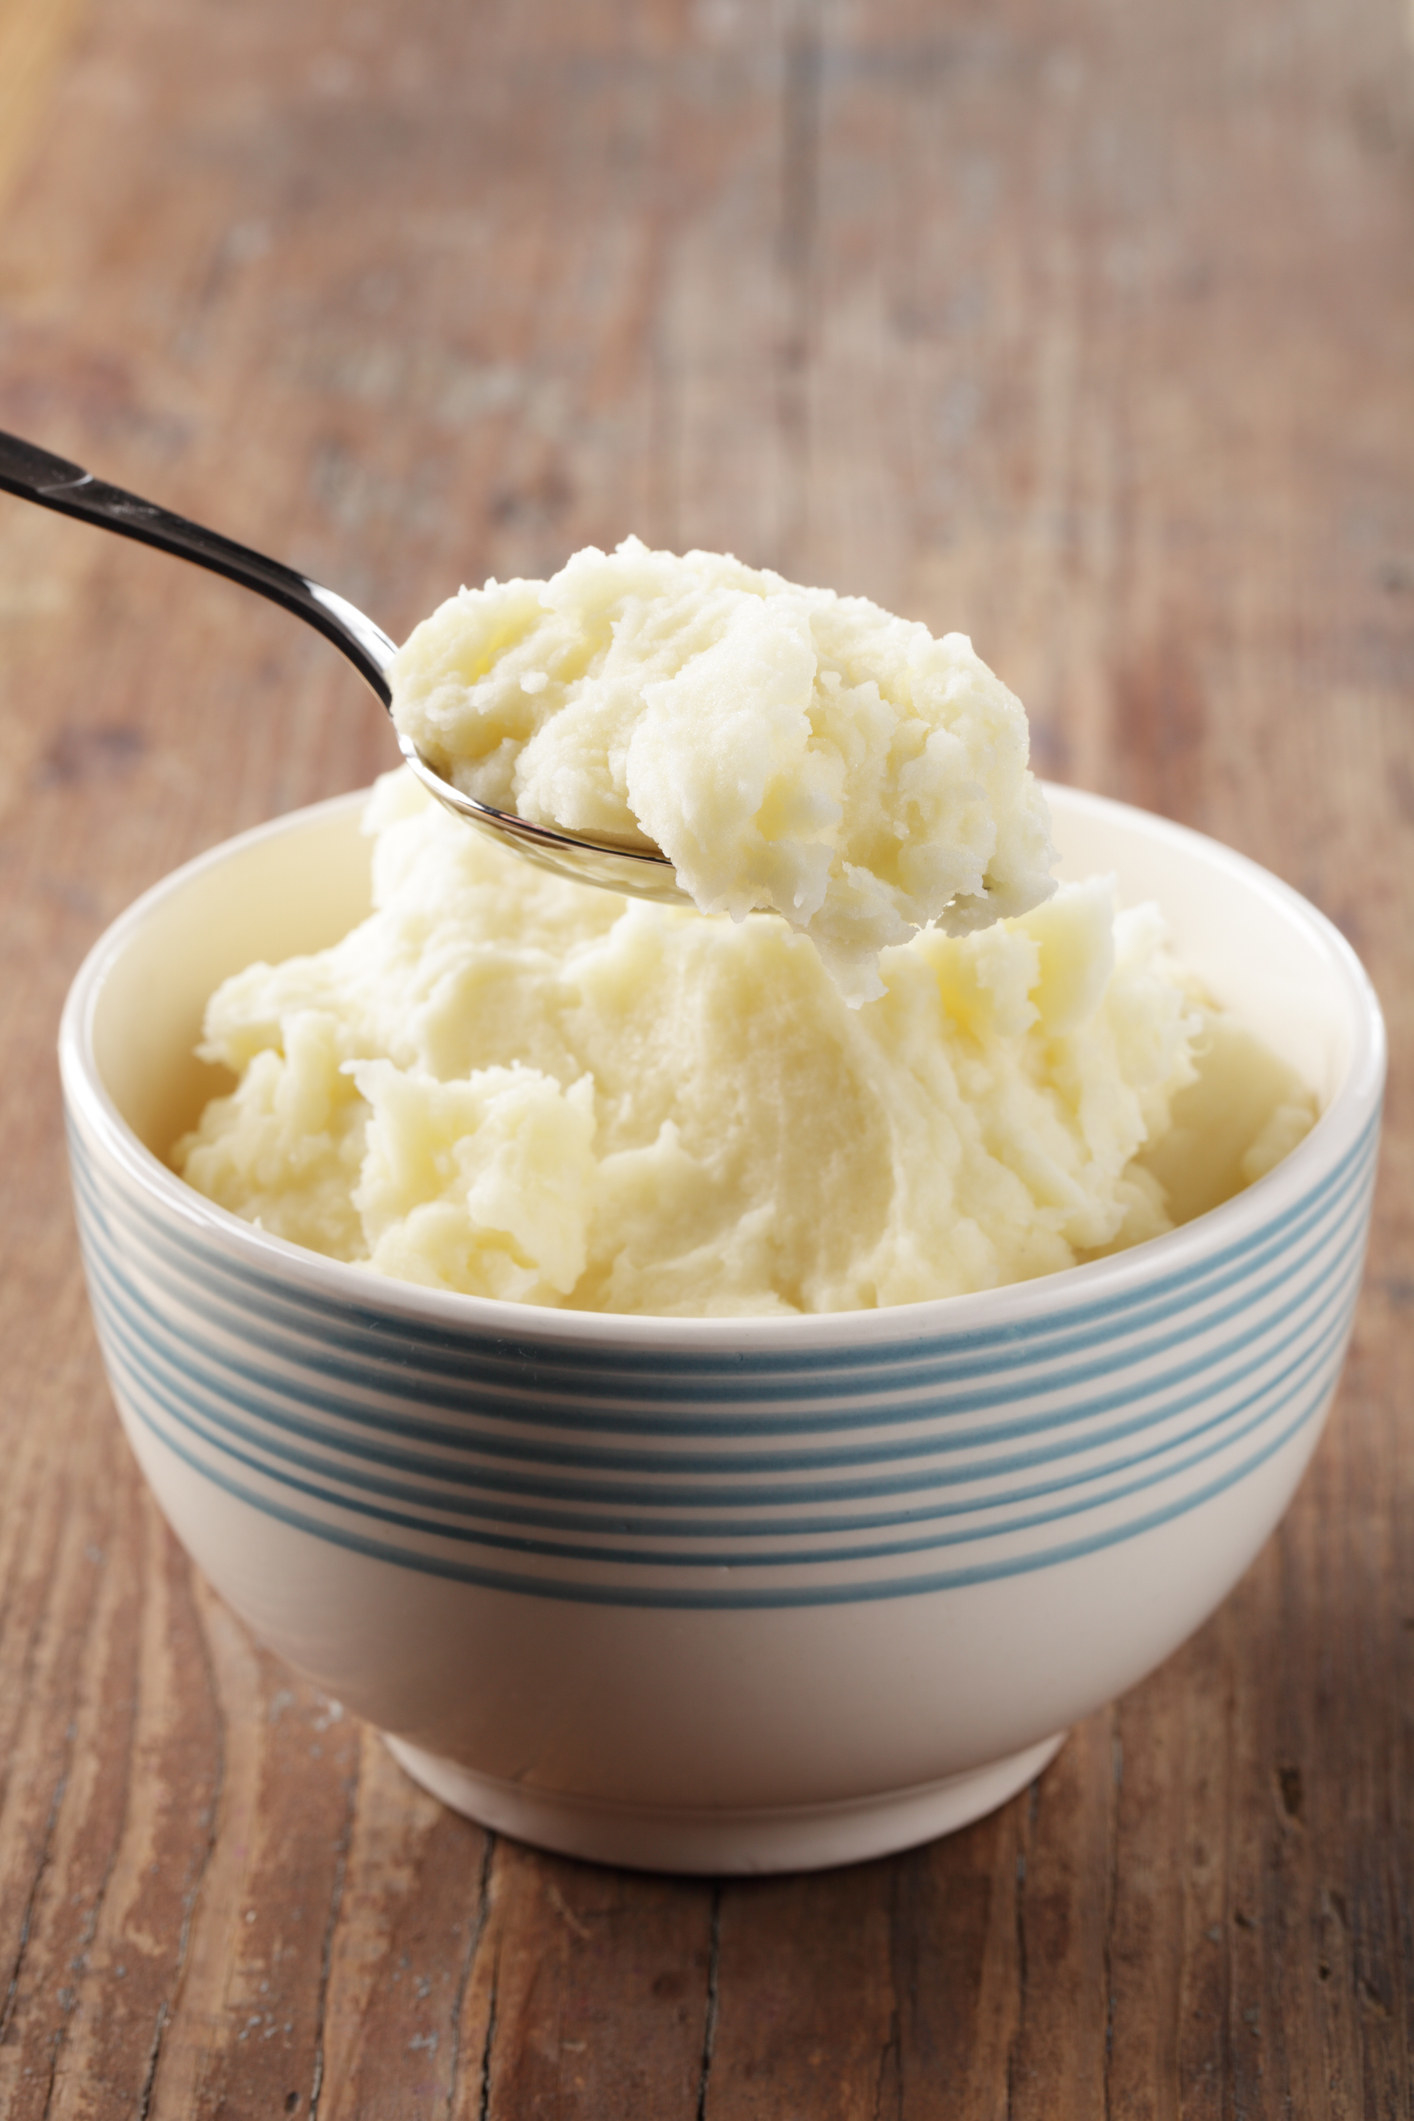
[61,789,1384,1871]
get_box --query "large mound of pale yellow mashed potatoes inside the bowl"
[174,774,1312,1315]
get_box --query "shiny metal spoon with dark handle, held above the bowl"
[0,433,691,904]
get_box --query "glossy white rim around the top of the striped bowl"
[59,783,1386,1355]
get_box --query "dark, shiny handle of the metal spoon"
[0,433,396,706]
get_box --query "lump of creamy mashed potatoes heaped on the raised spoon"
[392,539,1054,1003]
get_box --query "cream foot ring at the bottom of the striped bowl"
[384,1731,1064,1875]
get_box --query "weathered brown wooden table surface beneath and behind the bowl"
[0,0,1414,2121]
